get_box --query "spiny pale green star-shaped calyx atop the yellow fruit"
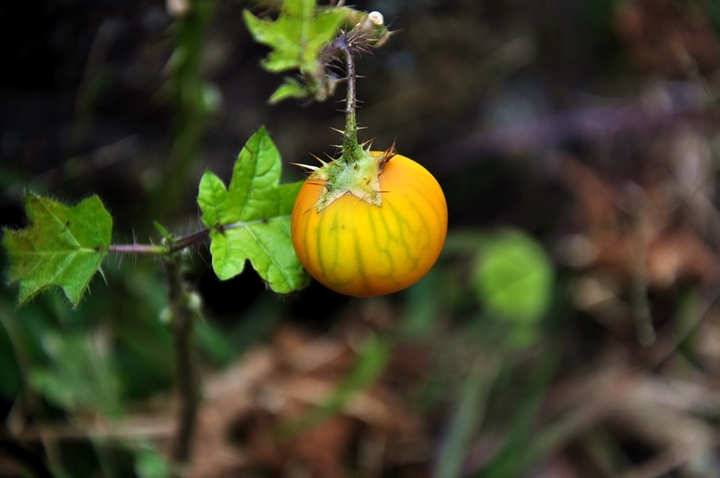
[299,144,395,213]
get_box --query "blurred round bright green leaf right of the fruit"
[474,231,554,324]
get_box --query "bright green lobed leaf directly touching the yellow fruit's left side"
[198,128,309,294]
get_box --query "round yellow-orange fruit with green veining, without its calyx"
[291,152,447,297]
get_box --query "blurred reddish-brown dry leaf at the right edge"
[560,157,720,288]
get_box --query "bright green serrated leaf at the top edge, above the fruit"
[244,0,345,72]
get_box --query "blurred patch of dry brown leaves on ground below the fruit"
[190,327,427,478]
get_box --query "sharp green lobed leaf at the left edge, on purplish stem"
[3,192,112,306]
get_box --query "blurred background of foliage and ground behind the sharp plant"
[0,0,720,478]
